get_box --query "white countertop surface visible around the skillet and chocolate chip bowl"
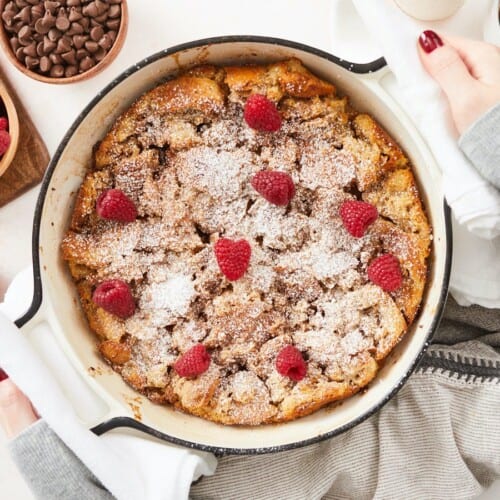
[0,0,500,500]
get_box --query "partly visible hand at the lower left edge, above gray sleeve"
[0,368,39,439]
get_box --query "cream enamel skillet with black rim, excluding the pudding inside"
[17,36,451,454]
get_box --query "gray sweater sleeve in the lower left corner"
[9,420,113,500]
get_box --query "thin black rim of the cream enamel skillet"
[15,35,452,456]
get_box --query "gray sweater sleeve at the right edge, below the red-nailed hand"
[458,103,500,189]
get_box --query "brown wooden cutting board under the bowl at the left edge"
[0,68,49,207]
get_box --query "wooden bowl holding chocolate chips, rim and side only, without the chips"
[0,0,128,84]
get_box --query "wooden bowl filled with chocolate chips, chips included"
[0,0,128,83]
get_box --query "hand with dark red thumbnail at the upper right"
[418,30,500,134]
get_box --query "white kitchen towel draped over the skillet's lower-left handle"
[0,270,217,500]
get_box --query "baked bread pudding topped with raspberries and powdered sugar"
[62,59,431,425]
